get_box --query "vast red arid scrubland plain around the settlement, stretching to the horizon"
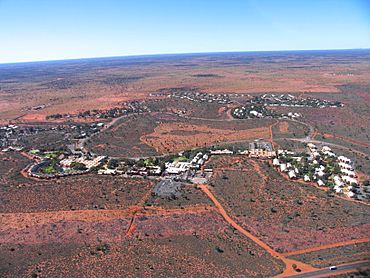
[0,50,370,277]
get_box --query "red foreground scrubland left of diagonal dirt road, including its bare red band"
[0,208,283,277]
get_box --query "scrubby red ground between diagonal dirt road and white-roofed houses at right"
[205,157,369,253]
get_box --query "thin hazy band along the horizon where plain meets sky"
[0,47,370,66]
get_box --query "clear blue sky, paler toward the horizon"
[0,0,370,63]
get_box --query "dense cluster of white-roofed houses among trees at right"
[272,143,359,197]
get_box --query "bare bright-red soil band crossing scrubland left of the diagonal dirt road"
[0,206,224,244]
